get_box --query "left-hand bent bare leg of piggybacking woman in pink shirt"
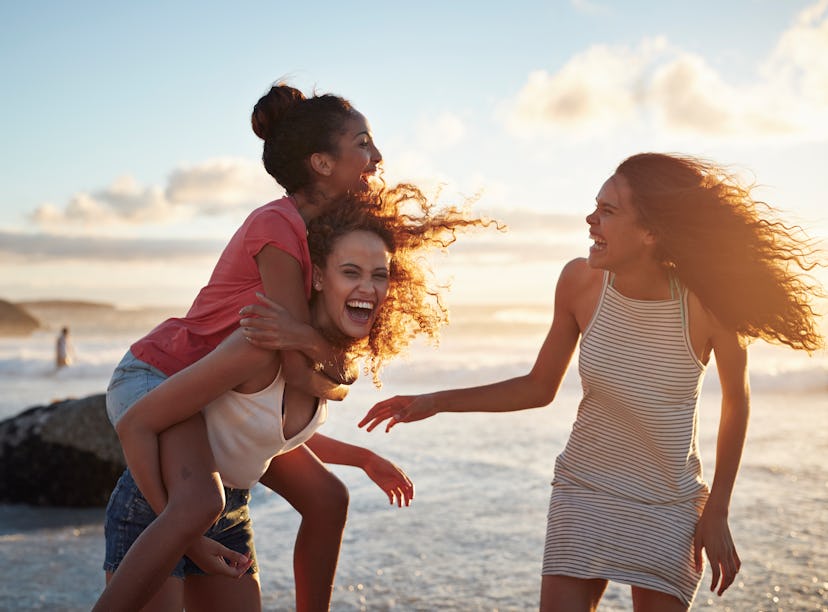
[93,413,224,612]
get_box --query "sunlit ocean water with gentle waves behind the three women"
[0,304,828,612]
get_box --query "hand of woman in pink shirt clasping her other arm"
[239,293,303,351]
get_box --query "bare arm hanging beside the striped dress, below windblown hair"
[694,327,750,595]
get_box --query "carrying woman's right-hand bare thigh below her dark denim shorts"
[184,574,262,612]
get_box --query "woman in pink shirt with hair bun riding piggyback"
[95,84,382,610]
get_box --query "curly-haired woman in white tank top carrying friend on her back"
[99,186,494,610]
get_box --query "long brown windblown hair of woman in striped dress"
[616,153,824,352]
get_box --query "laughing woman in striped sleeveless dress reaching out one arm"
[360,153,822,611]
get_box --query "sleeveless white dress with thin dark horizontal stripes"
[543,272,708,605]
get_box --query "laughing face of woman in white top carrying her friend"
[313,230,391,338]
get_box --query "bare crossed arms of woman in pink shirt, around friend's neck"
[252,246,356,384]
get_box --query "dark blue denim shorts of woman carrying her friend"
[103,469,259,578]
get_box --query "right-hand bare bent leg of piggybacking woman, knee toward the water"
[260,446,349,612]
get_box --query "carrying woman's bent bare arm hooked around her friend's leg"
[116,332,277,513]
